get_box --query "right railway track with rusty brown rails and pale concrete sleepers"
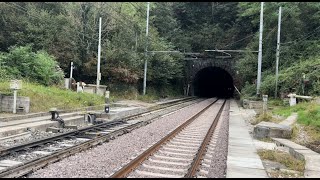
[111,100,229,178]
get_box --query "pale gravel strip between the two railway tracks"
[29,99,213,178]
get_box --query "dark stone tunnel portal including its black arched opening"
[184,54,242,98]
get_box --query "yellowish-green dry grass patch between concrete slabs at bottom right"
[258,150,305,172]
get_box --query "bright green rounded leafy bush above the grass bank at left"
[0,45,64,85]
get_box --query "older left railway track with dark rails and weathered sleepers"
[0,98,201,177]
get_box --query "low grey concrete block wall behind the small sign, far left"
[0,95,30,113]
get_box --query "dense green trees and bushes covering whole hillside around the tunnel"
[0,2,320,96]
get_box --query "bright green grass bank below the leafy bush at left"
[0,81,105,113]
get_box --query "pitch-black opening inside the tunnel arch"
[193,67,234,98]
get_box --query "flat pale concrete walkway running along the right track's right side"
[226,100,268,178]
